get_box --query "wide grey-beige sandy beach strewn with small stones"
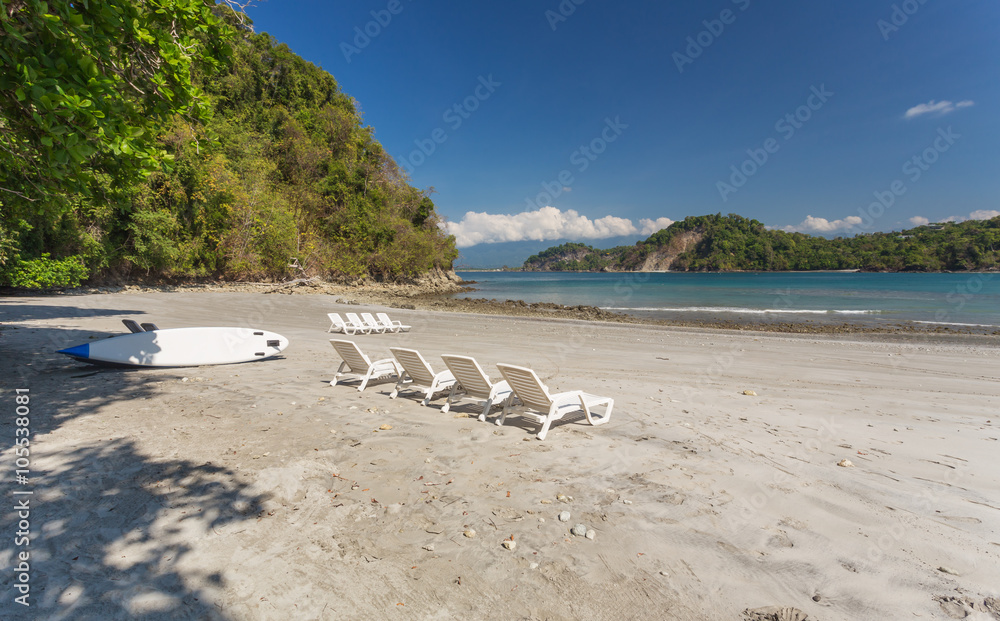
[0,292,1000,621]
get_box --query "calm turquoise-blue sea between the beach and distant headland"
[455,272,1000,327]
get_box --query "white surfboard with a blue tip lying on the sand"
[57,328,288,367]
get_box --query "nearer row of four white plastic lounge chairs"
[330,339,615,440]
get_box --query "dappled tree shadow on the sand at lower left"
[0,330,268,621]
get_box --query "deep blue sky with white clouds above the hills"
[248,0,1000,254]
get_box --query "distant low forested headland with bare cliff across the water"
[524,214,1000,272]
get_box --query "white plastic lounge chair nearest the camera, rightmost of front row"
[496,364,615,440]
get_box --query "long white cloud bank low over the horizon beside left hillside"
[443,207,674,248]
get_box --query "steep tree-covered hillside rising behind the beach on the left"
[0,0,457,288]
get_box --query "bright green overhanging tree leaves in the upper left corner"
[0,0,232,201]
